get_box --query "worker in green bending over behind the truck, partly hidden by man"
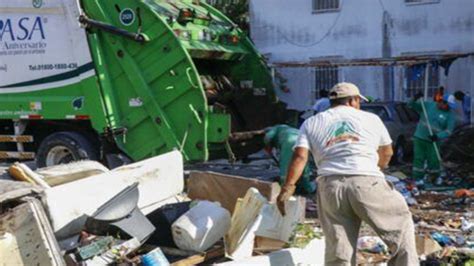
[264,125,316,193]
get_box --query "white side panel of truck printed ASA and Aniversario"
[0,0,95,93]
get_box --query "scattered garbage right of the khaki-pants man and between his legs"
[358,171,474,265]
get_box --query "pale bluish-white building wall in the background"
[250,0,474,110]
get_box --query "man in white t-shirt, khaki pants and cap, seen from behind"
[277,83,419,265]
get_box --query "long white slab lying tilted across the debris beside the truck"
[45,151,184,239]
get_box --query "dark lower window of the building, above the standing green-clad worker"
[405,65,439,98]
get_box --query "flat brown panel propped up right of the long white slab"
[188,171,280,213]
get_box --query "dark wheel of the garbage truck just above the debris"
[36,131,99,167]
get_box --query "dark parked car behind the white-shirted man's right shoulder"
[361,102,420,164]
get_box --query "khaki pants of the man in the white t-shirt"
[317,176,419,266]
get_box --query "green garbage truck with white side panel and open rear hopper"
[0,0,285,166]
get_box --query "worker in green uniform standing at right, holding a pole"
[408,93,456,180]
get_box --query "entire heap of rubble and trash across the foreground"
[0,152,474,265]
